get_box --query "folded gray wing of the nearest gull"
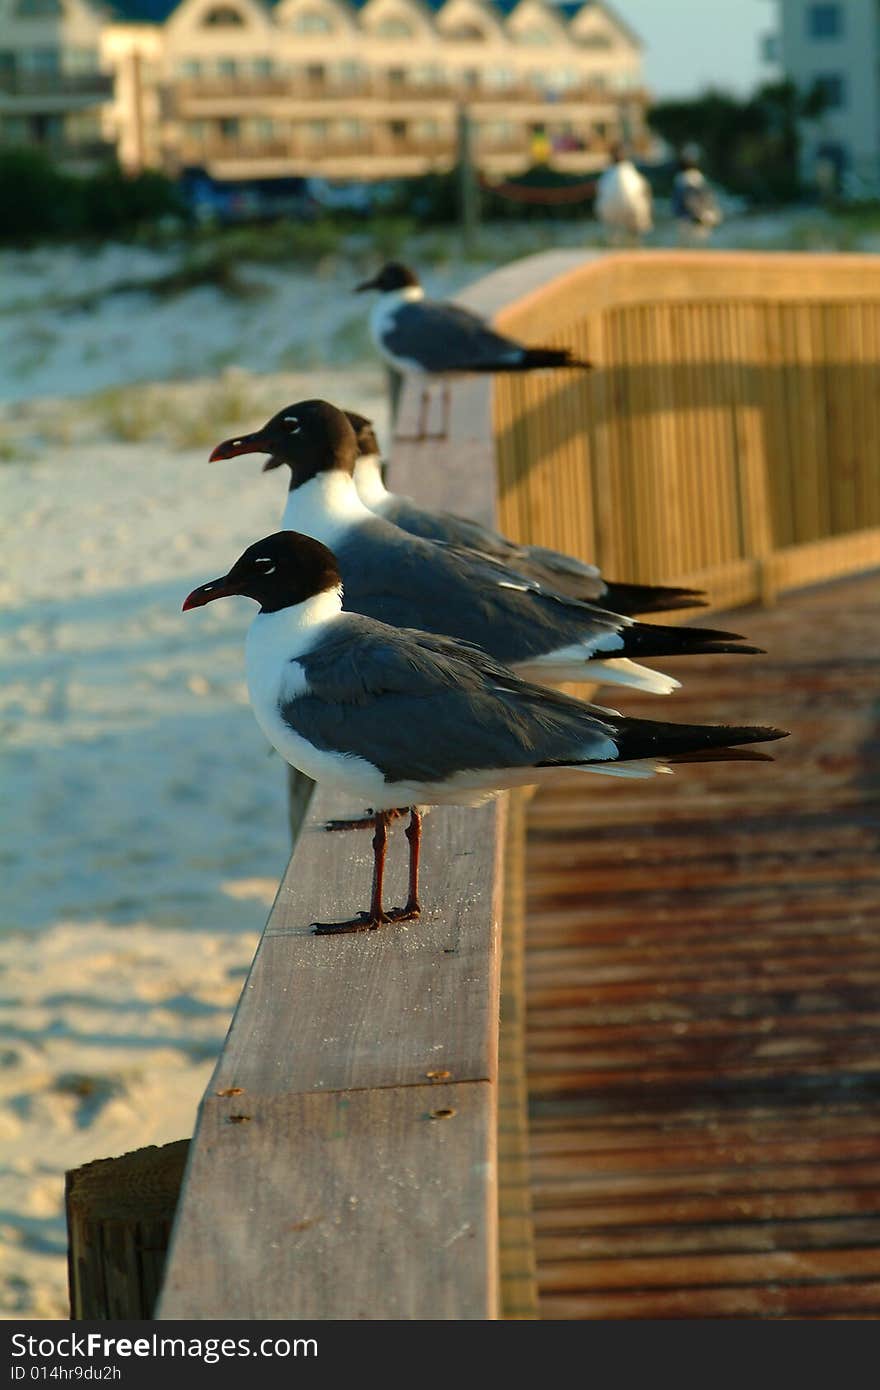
[287,614,614,783]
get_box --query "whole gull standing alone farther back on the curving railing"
[355,261,591,439]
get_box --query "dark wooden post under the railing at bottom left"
[65,1138,189,1321]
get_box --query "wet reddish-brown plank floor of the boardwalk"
[525,575,880,1319]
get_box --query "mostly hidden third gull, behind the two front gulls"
[329,410,705,614]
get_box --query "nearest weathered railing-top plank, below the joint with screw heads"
[158,1081,498,1321]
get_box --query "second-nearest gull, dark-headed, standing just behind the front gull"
[210,400,759,694]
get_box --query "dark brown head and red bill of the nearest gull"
[182,531,342,613]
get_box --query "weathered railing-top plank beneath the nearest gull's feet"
[210,791,503,1095]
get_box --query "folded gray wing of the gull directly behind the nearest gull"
[336,517,626,666]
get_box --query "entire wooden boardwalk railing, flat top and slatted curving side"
[143,253,880,1319]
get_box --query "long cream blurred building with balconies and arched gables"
[0,0,645,179]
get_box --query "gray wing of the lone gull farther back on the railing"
[384,299,523,373]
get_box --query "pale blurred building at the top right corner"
[772,0,880,193]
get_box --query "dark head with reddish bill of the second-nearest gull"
[209,400,360,489]
